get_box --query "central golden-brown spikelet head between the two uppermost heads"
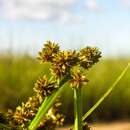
[51,51,78,77]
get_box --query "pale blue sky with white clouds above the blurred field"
[0,0,130,56]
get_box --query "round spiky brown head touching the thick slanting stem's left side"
[33,75,57,97]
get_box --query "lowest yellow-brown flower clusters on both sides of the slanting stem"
[7,96,64,130]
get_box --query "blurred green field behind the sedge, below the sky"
[0,54,130,122]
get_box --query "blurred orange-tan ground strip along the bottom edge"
[57,122,130,130]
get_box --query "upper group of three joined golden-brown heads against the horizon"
[39,41,101,77]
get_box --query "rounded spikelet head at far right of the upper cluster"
[79,47,101,69]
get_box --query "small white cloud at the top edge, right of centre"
[86,0,101,11]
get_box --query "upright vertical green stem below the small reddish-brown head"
[74,87,82,130]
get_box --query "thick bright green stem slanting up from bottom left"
[28,76,68,130]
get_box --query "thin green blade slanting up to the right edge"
[82,63,130,121]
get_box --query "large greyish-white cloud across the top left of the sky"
[0,0,78,22]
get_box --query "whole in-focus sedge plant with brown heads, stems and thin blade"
[0,41,129,130]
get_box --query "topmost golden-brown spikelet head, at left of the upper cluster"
[38,41,59,62]
